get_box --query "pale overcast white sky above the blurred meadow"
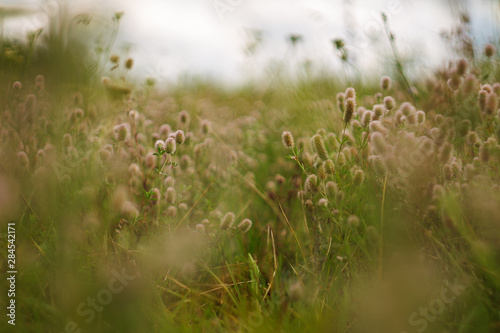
[0,0,499,83]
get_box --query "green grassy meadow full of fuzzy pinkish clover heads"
[0,5,500,333]
